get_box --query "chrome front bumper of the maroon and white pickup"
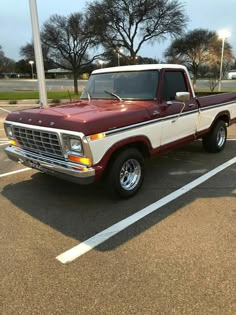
[5,146,95,184]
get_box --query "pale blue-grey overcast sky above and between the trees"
[0,0,236,60]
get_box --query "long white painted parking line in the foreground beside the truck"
[56,157,236,264]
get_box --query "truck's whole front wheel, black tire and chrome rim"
[107,148,144,198]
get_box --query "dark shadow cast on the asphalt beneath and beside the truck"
[2,143,236,251]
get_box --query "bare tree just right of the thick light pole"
[41,13,100,94]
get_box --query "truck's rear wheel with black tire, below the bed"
[202,120,227,153]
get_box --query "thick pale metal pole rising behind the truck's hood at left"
[29,0,48,107]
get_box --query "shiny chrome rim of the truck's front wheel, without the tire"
[120,159,142,190]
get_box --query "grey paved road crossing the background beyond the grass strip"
[0,79,236,92]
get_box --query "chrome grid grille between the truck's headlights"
[13,126,63,158]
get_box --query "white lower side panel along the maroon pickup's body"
[89,103,236,164]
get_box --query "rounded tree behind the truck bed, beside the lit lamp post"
[165,29,233,86]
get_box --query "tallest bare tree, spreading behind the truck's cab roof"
[88,0,188,64]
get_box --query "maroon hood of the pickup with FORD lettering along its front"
[7,100,156,135]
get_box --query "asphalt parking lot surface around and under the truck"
[0,107,236,315]
